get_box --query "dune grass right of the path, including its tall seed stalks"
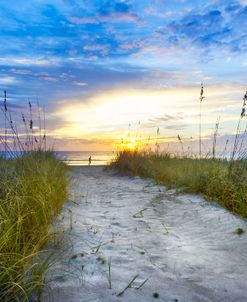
[110,88,247,218]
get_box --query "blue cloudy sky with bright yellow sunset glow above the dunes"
[0,0,247,150]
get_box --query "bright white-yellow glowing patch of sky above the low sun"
[47,85,245,150]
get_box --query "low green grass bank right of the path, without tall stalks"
[110,151,247,218]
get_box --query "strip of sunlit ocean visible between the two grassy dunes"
[56,151,116,166]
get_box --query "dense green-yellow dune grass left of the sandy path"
[0,151,68,302]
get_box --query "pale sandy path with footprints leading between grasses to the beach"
[43,167,247,302]
